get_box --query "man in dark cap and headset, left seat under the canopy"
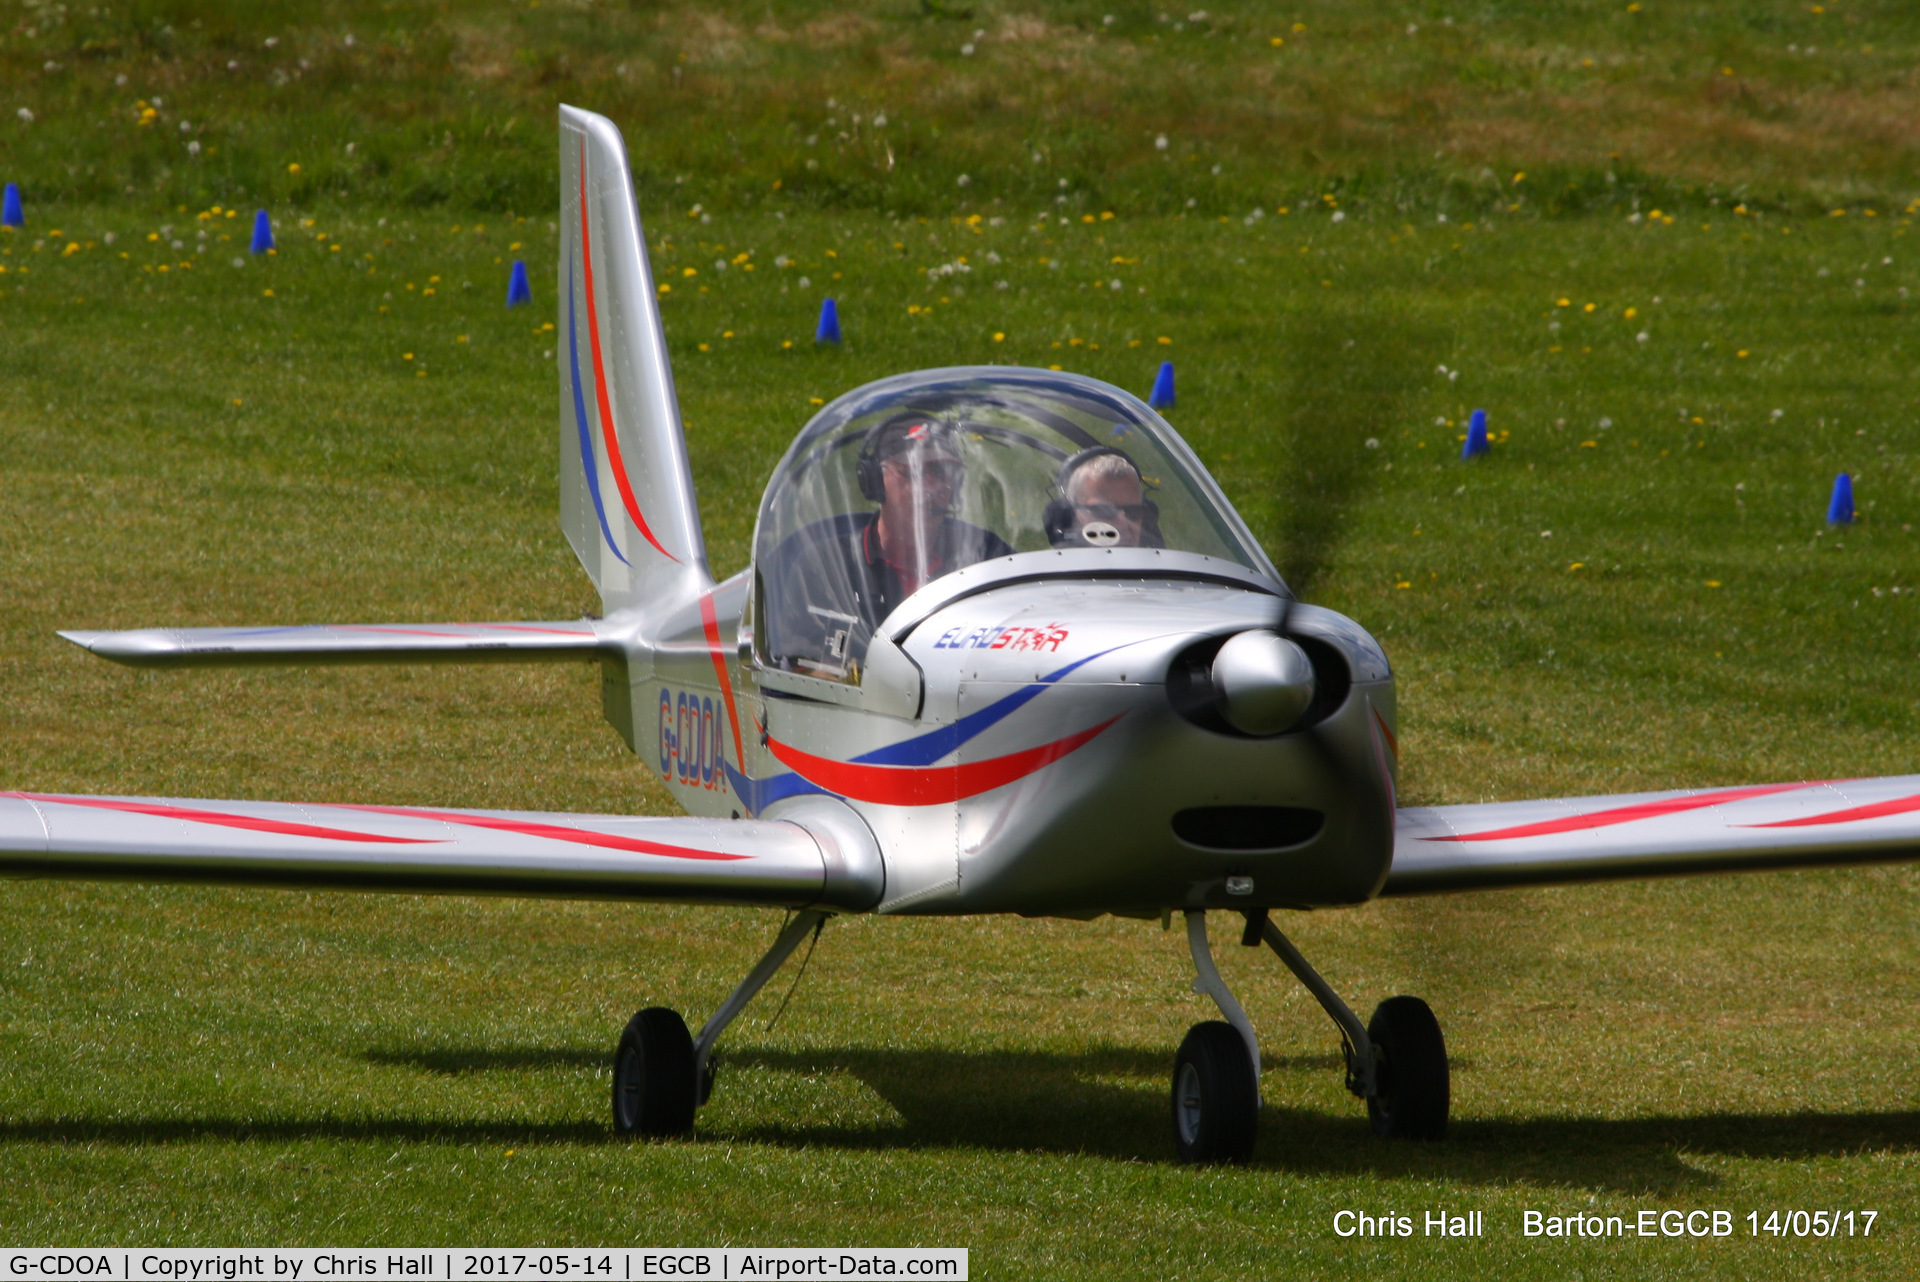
[762,413,1014,679]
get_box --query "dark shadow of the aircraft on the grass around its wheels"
[0,1046,1920,1194]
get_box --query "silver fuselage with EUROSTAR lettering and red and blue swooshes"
[622,549,1396,915]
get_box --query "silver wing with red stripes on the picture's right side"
[1380,775,1920,896]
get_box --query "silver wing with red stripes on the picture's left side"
[0,793,883,912]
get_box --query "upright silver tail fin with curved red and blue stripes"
[555,106,712,610]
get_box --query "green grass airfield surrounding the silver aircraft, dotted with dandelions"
[0,4,1920,1276]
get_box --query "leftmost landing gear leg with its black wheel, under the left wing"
[612,908,828,1140]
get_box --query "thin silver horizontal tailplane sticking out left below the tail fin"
[60,620,612,668]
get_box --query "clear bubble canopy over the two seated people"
[753,367,1277,681]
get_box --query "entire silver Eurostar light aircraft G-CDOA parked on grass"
[15,106,1920,1161]
